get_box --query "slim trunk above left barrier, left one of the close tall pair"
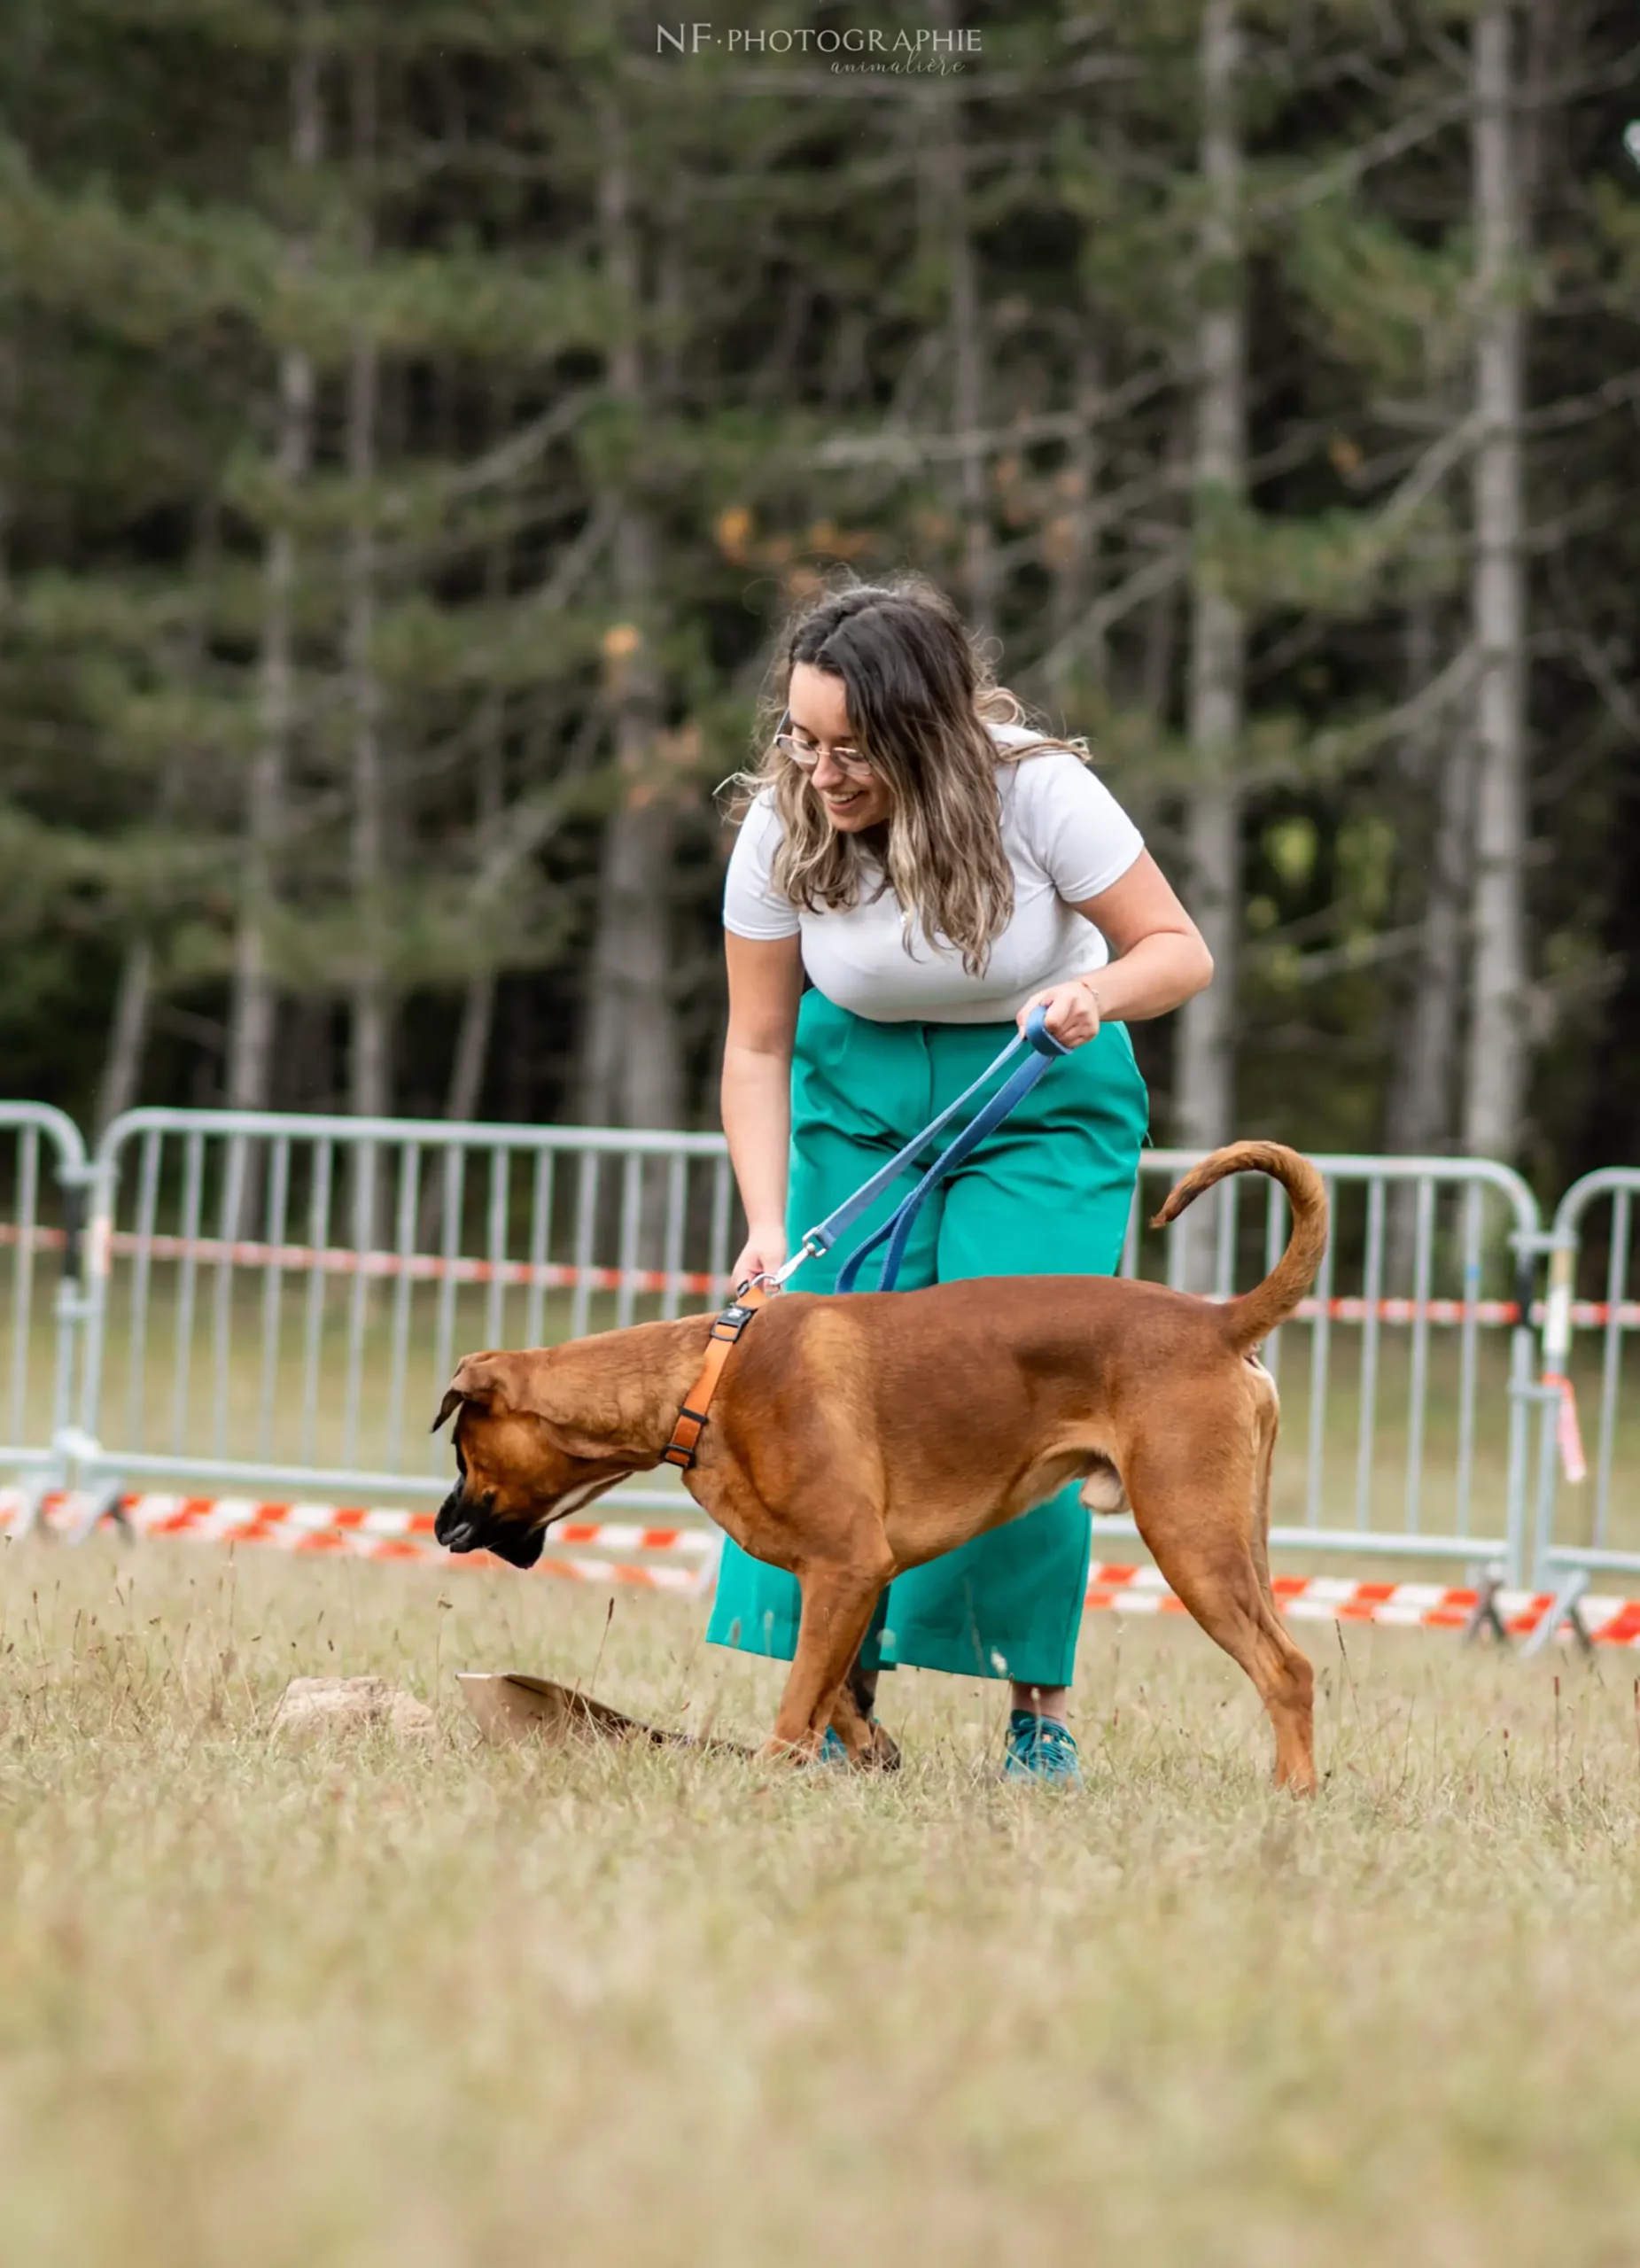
[227,7,323,1111]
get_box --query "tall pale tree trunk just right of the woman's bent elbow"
[1175,0,1247,1284]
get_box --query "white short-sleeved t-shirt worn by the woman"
[724,726,1146,1023]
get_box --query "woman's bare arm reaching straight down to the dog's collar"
[721,932,803,1284]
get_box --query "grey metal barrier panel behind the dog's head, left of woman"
[82,1109,733,1508]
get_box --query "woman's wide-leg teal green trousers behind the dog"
[705,991,1147,1685]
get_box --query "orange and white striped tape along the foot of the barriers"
[0,1490,1640,1647]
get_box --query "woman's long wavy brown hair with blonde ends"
[726,574,1086,977]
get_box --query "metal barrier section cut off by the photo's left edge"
[0,1102,90,1524]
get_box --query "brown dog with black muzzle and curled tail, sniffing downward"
[433,1141,1327,1791]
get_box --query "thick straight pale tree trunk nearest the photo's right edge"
[1463,0,1527,1159]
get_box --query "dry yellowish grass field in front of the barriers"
[0,1542,1640,2268]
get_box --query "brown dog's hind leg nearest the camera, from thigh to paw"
[1125,1404,1316,1797]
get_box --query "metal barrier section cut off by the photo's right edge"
[1534,1166,1640,1624]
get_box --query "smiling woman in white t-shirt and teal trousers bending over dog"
[708,579,1211,1781]
